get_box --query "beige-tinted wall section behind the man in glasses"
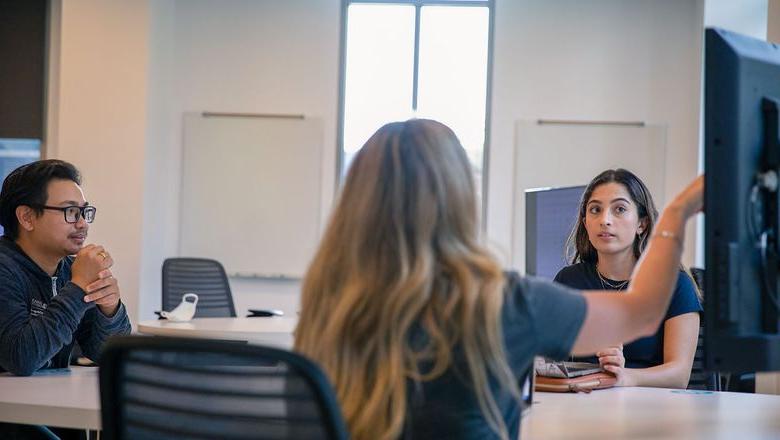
[46,0,148,324]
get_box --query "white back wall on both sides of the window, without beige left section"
[154,0,703,311]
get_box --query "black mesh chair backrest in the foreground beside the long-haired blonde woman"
[100,336,347,440]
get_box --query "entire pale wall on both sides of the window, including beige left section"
[50,0,720,320]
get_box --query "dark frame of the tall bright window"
[335,0,495,227]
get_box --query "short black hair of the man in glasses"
[0,159,81,240]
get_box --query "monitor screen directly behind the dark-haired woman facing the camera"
[525,186,585,279]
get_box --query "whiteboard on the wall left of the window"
[179,113,322,278]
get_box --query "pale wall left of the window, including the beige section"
[46,0,340,322]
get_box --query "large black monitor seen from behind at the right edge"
[704,29,780,372]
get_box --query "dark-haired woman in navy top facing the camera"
[555,169,702,388]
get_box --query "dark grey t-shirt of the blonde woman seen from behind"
[403,272,586,439]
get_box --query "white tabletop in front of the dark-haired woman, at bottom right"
[520,388,780,440]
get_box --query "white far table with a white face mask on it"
[138,316,298,350]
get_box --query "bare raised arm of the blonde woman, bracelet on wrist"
[572,176,704,355]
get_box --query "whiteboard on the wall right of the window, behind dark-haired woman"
[512,120,666,268]
